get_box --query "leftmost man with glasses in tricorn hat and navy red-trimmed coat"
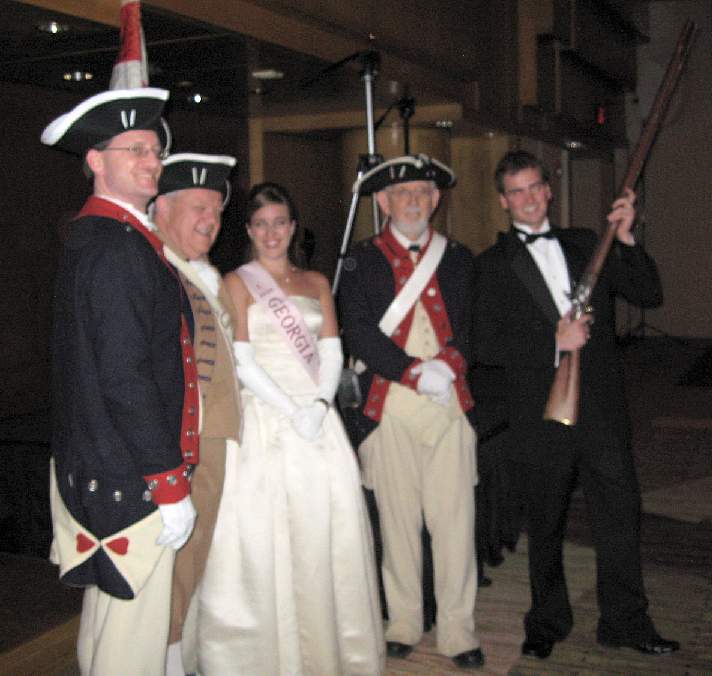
[42,88,198,676]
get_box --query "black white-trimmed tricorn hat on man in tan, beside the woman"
[158,153,237,204]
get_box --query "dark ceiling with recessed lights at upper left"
[0,0,400,116]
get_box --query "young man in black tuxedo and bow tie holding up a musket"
[474,151,679,659]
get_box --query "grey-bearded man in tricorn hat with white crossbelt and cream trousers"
[339,155,484,669]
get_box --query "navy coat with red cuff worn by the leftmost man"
[52,203,197,598]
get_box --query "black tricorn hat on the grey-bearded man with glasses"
[353,153,455,195]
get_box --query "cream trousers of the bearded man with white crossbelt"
[359,404,479,656]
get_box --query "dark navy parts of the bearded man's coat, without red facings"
[339,239,474,448]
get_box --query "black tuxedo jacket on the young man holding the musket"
[474,228,662,454]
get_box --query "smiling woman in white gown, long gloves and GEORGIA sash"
[198,184,384,676]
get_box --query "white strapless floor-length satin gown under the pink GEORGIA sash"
[198,296,384,676]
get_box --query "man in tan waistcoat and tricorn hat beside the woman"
[149,153,240,676]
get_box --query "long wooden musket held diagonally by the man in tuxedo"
[544,19,696,425]
